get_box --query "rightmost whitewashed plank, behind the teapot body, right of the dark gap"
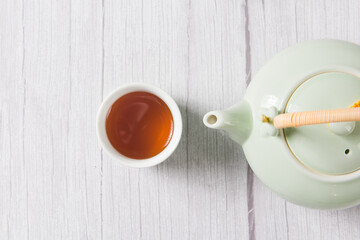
[249,0,360,239]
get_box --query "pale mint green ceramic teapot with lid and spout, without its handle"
[204,40,360,209]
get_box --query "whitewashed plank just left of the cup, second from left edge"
[3,1,102,239]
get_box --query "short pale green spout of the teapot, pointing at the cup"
[203,101,252,144]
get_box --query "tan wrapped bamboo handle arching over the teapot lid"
[274,108,360,129]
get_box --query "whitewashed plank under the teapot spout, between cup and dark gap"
[187,1,248,239]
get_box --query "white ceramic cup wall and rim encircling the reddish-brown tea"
[96,83,182,168]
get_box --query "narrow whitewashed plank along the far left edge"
[0,0,29,239]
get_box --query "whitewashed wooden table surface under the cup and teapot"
[0,0,360,240]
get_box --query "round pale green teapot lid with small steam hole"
[284,72,360,175]
